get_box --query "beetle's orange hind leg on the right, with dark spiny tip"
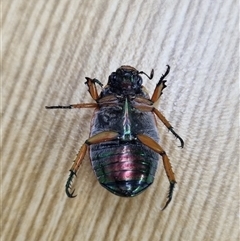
[137,134,177,210]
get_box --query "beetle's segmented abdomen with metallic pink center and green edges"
[90,142,159,197]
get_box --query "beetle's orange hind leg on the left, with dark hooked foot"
[65,131,119,198]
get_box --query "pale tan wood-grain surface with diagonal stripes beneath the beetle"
[1,0,239,241]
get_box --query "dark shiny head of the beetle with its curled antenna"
[108,65,153,95]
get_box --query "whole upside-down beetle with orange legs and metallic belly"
[45,65,184,210]
